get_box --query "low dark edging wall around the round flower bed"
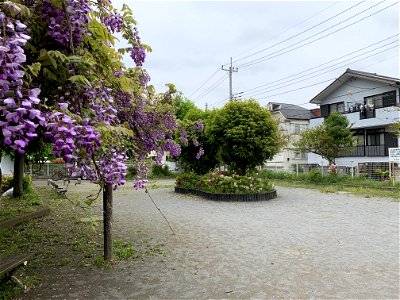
[175,186,277,202]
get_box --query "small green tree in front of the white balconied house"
[294,112,356,164]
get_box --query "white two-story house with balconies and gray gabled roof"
[308,69,400,177]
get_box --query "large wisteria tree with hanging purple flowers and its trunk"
[0,0,184,260]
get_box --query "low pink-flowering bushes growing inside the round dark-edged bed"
[176,172,273,194]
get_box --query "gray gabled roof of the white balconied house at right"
[310,69,400,104]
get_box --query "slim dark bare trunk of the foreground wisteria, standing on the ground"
[103,183,113,260]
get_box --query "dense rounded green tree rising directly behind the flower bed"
[206,100,283,175]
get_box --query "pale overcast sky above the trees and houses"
[113,0,399,109]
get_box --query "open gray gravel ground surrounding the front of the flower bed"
[23,184,399,299]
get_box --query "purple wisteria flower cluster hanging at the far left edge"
[0,7,46,154]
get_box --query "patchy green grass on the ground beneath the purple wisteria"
[0,183,170,300]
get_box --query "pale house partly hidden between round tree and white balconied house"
[266,102,318,170]
